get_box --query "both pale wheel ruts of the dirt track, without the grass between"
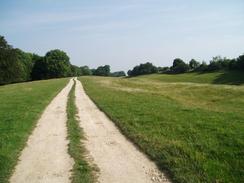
[10,80,169,183]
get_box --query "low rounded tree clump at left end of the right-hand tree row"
[127,62,158,76]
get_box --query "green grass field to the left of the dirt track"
[0,79,68,182]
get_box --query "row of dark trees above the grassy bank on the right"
[127,54,244,76]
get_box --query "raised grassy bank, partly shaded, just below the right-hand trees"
[134,71,244,85]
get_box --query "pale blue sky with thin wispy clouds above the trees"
[0,0,244,71]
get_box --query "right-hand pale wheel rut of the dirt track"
[75,80,169,183]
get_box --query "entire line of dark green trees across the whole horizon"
[0,36,244,85]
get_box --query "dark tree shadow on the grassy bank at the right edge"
[212,71,244,85]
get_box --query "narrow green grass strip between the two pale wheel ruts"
[67,79,95,183]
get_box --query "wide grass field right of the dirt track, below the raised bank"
[79,75,244,183]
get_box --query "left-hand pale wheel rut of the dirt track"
[10,79,73,183]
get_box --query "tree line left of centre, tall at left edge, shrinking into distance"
[0,36,125,85]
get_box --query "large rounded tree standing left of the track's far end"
[44,49,71,78]
